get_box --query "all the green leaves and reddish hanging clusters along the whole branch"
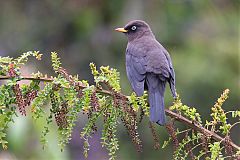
[0,51,240,160]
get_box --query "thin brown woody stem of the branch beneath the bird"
[0,76,240,150]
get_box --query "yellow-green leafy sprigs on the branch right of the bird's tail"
[166,89,240,160]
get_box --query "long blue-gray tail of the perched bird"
[148,80,166,125]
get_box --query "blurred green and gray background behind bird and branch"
[0,0,240,160]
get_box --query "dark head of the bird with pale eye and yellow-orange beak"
[115,20,154,41]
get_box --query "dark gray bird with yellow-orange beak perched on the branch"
[115,20,176,125]
